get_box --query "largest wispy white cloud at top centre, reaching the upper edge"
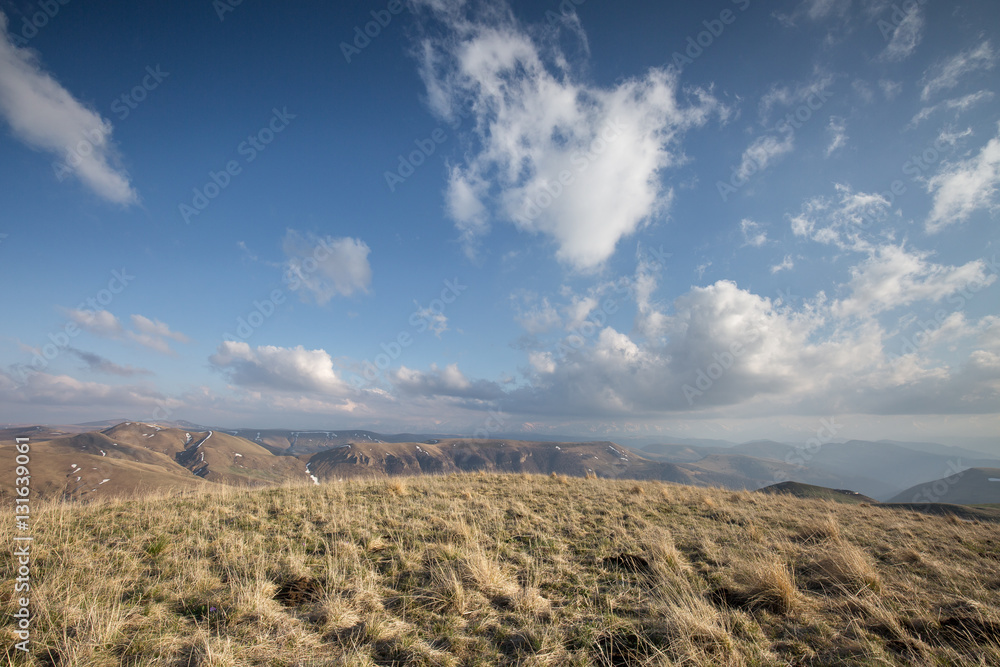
[416,1,724,270]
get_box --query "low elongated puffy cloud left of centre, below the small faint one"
[209,341,349,396]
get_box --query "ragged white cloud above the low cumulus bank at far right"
[831,245,996,317]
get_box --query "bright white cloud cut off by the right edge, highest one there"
[925,126,1000,234]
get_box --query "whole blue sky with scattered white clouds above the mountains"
[0,0,1000,445]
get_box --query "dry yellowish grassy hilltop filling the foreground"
[0,474,1000,667]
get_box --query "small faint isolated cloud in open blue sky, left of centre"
[282,229,372,305]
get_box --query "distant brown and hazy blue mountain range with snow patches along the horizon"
[0,420,1000,504]
